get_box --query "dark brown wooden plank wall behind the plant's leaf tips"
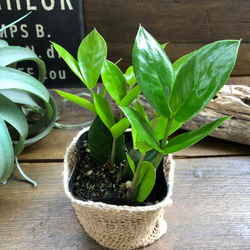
[83,0,250,76]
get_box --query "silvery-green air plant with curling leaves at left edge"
[0,15,57,186]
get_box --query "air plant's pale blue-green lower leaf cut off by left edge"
[0,114,14,183]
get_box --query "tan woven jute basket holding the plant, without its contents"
[64,128,175,250]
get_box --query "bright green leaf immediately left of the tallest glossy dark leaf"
[102,60,127,105]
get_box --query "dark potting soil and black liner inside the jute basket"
[69,133,168,206]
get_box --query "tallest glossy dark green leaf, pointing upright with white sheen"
[132,27,174,117]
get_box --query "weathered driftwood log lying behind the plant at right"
[182,85,250,145]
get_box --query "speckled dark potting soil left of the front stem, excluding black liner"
[72,140,127,200]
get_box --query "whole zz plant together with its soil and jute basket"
[53,27,240,249]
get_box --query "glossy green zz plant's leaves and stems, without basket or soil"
[53,27,240,201]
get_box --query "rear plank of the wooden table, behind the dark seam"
[18,88,250,162]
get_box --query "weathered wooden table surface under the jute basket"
[0,89,250,250]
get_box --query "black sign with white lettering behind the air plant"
[0,0,84,88]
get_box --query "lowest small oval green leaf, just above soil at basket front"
[133,161,156,202]
